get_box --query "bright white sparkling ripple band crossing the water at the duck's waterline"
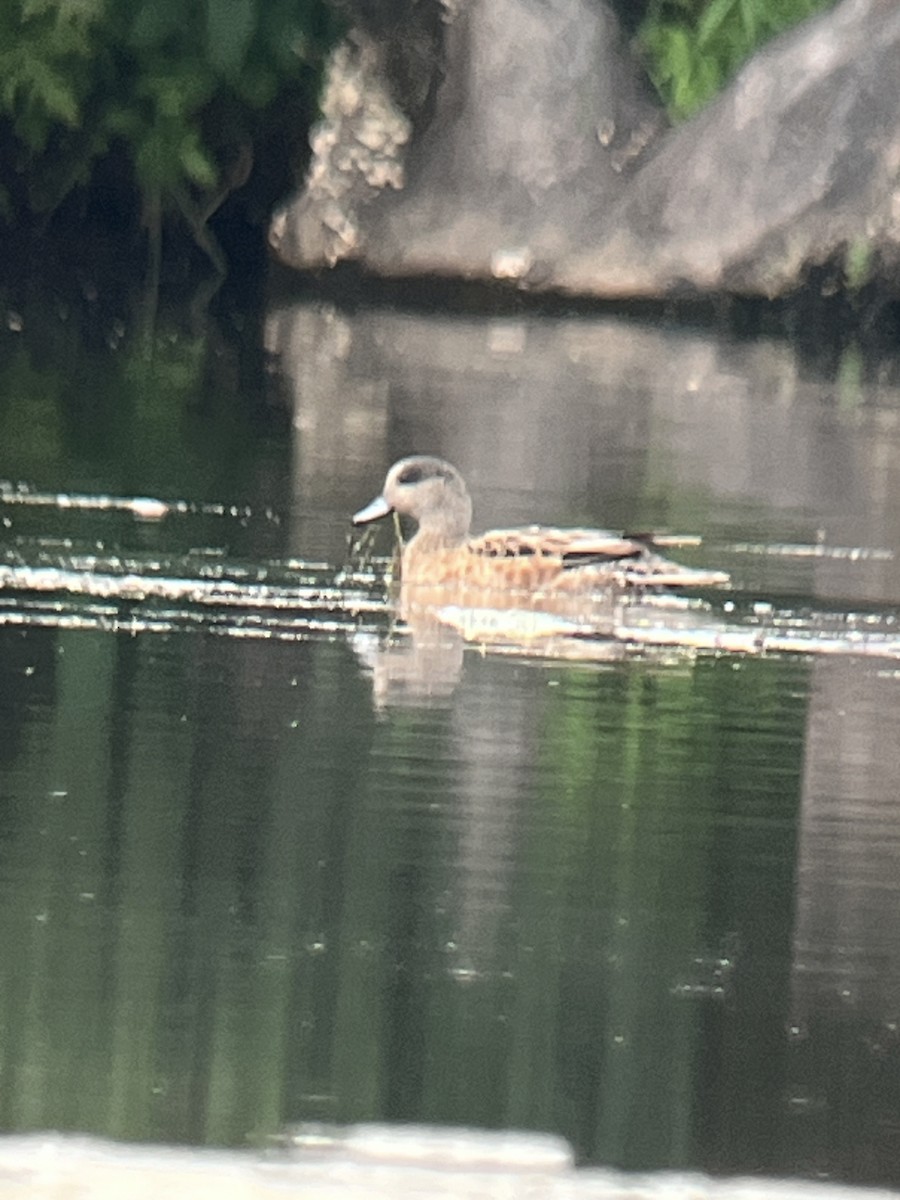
[0,550,900,660]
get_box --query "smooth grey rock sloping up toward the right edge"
[548,0,900,298]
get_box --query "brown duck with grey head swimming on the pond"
[352,455,730,604]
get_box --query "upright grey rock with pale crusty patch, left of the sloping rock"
[271,0,665,278]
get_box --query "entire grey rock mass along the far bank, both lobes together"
[271,0,900,298]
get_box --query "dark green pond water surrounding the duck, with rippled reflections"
[0,301,900,1186]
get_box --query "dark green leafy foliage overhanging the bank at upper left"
[0,0,335,215]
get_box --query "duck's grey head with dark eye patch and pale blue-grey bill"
[353,455,472,544]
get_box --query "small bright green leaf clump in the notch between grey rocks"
[638,0,834,118]
